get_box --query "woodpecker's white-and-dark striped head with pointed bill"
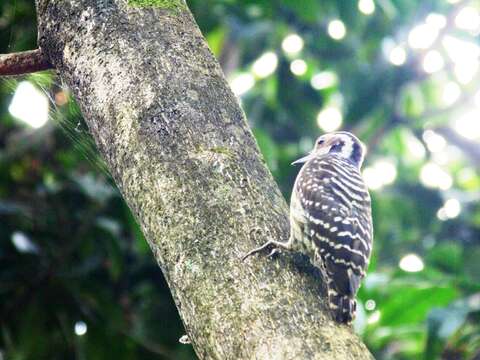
[292,131,366,168]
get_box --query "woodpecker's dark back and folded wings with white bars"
[296,159,372,296]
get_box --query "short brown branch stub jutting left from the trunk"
[0,49,53,76]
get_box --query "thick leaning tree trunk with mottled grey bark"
[37,0,371,360]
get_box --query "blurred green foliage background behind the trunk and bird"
[0,0,480,360]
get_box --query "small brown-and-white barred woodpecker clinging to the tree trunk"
[243,131,373,324]
